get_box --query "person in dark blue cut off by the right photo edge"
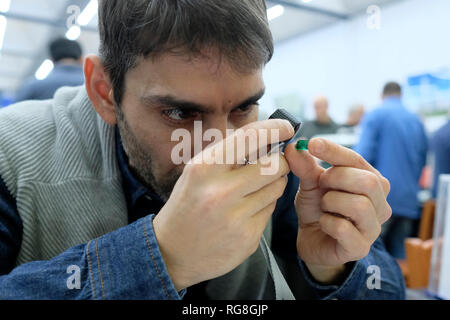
[430,121,450,198]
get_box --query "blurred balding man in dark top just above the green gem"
[302,96,339,139]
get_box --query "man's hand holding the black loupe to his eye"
[153,120,294,291]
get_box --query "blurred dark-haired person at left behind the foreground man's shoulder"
[16,38,84,102]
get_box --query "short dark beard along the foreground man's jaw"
[116,106,183,202]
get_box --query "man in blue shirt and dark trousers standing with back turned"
[354,82,428,259]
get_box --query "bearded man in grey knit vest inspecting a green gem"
[0,0,404,299]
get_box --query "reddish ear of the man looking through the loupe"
[84,55,117,125]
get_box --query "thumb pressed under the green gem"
[284,143,325,191]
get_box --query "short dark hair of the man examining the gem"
[99,0,274,105]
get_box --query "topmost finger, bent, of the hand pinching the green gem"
[308,138,390,196]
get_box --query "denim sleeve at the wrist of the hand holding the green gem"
[298,238,406,300]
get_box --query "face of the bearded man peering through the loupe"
[117,54,264,200]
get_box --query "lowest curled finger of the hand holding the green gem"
[319,214,371,261]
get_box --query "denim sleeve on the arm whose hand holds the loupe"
[0,215,186,300]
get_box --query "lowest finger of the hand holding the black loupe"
[234,176,288,219]
